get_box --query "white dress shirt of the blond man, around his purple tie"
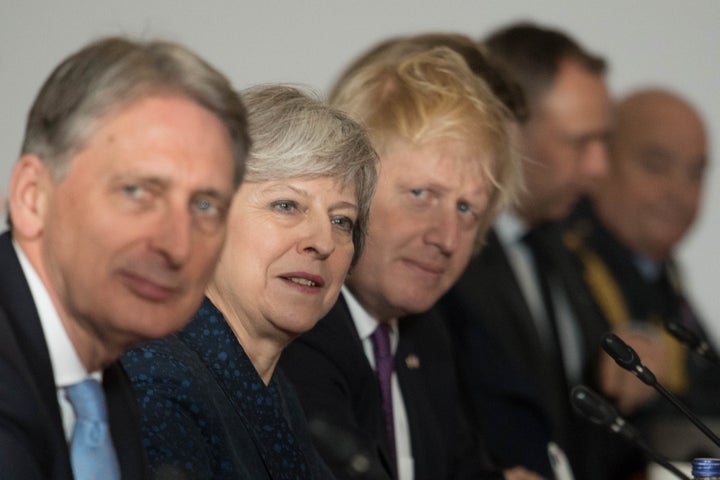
[342,286,415,480]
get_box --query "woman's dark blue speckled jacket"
[122,299,332,480]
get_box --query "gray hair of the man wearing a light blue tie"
[22,37,250,187]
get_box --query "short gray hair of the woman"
[241,85,377,265]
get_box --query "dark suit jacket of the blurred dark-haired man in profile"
[438,227,607,479]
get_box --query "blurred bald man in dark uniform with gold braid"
[566,89,720,452]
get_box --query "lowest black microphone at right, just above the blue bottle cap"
[570,385,690,480]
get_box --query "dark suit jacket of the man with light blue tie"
[0,233,147,480]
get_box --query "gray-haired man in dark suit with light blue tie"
[0,38,248,480]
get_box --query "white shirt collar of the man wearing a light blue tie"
[13,240,88,388]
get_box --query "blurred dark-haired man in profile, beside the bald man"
[441,24,610,479]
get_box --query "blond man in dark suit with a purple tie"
[281,43,538,480]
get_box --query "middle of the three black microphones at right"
[602,333,720,447]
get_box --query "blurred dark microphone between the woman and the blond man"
[308,417,389,480]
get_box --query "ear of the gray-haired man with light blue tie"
[8,154,53,239]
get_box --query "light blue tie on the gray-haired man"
[65,378,120,480]
